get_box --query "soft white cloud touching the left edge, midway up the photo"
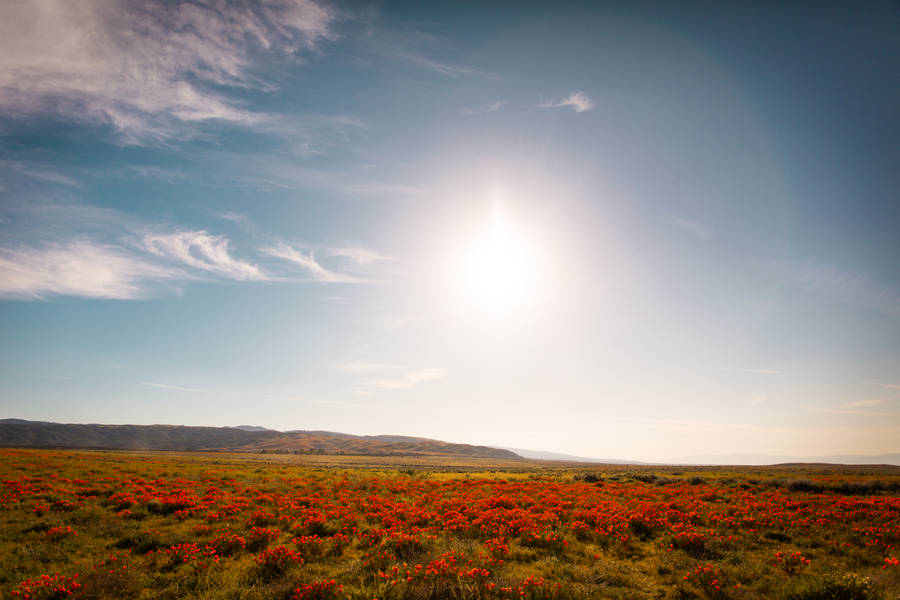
[0,240,185,300]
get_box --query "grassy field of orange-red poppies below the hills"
[0,449,900,600]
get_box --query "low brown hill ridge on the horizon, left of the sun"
[0,419,521,460]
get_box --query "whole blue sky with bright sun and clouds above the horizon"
[0,0,900,461]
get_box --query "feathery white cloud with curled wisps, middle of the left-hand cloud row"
[143,231,269,281]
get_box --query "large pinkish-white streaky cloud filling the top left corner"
[0,0,336,143]
